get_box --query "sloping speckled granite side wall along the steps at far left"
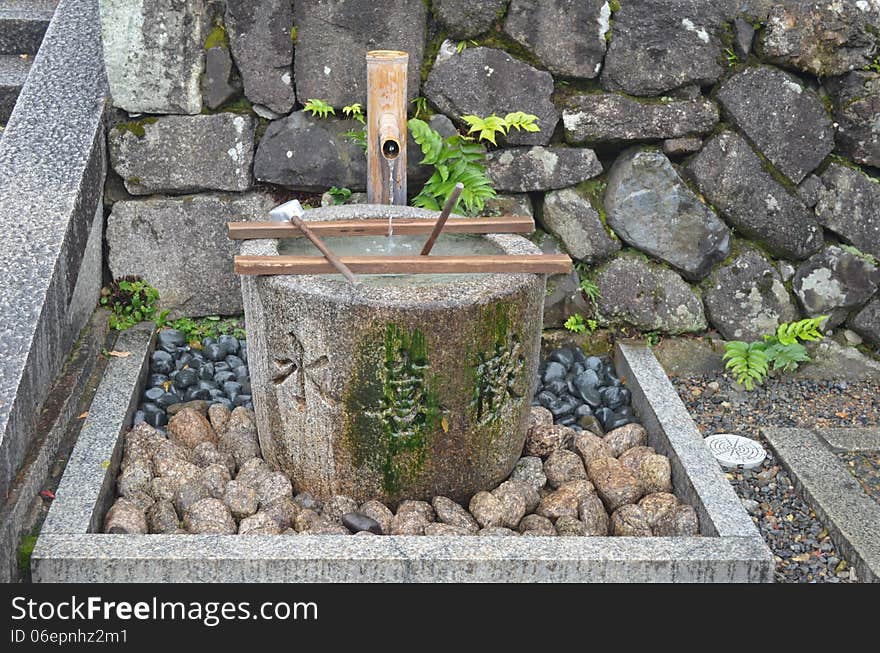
[0,0,106,498]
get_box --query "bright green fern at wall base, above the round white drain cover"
[723,315,828,390]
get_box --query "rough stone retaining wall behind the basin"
[101,0,880,342]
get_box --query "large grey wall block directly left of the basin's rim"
[107,193,277,317]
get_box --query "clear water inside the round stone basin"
[278,234,503,286]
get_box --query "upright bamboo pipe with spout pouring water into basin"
[367,50,409,206]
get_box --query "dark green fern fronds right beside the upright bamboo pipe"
[407,118,495,215]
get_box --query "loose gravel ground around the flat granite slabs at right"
[672,375,880,583]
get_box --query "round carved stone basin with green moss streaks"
[242,205,546,503]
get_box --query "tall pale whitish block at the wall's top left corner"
[99,0,206,114]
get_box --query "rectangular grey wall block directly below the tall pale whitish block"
[108,113,256,195]
